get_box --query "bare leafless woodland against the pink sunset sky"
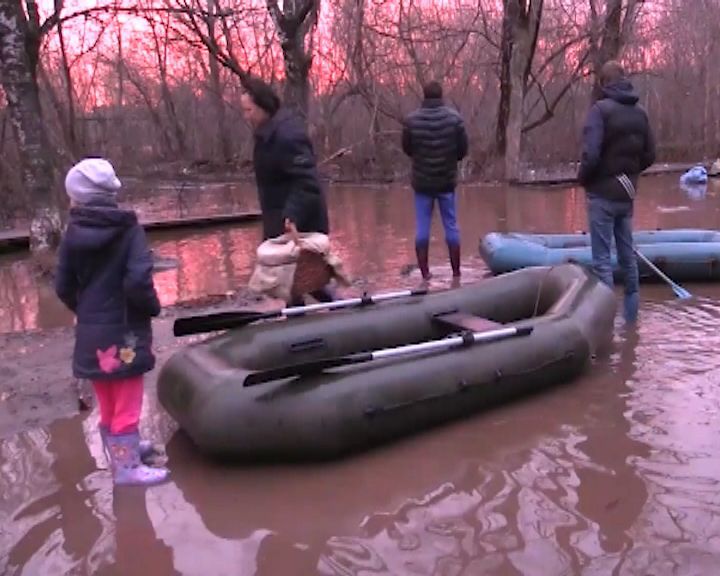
[0,0,720,197]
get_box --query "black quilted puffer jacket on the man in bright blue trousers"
[402,98,468,195]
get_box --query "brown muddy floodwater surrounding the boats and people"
[0,175,720,576]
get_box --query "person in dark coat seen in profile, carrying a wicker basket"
[240,78,333,306]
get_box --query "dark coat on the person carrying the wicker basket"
[253,109,329,239]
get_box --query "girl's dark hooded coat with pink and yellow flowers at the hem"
[55,205,160,380]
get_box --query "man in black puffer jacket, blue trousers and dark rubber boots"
[402,82,468,280]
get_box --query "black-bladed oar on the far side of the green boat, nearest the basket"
[173,288,427,336]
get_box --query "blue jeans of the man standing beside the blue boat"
[588,196,640,321]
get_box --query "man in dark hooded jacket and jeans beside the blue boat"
[578,60,655,322]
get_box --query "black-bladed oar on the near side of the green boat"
[243,326,533,386]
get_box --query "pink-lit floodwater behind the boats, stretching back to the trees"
[5,175,720,332]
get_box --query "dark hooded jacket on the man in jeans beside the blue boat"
[578,80,655,200]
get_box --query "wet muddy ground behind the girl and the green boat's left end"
[0,294,272,438]
